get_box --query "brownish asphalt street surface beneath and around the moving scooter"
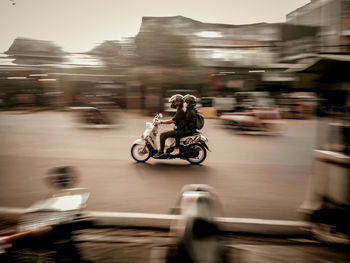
[0,111,316,220]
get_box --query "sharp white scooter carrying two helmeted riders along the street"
[131,113,210,164]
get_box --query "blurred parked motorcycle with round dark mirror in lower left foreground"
[0,167,92,262]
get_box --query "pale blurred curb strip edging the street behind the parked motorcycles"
[0,207,311,236]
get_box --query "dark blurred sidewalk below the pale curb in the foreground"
[77,228,350,263]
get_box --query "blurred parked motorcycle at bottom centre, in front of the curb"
[166,184,229,262]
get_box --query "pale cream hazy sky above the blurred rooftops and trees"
[0,0,310,53]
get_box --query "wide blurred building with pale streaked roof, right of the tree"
[140,16,318,96]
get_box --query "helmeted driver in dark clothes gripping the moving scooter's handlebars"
[153,94,185,158]
